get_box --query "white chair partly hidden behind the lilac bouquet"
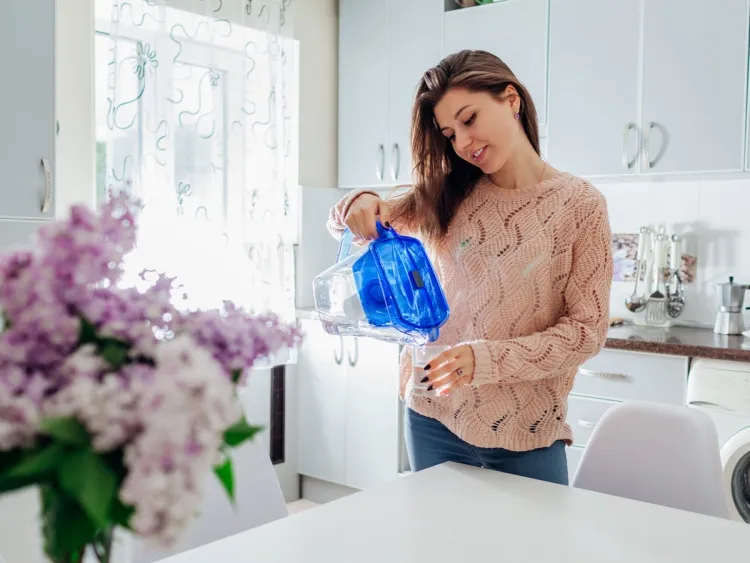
[132,437,288,563]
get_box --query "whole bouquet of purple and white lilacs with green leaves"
[0,195,301,562]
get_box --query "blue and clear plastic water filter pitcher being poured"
[313,222,450,346]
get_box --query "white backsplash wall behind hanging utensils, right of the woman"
[594,178,750,325]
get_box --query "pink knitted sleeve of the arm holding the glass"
[468,193,613,386]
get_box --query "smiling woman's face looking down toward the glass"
[435,86,524,174]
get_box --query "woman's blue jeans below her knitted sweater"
[404,408,568,485]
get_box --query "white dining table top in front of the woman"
[163,463,750,563]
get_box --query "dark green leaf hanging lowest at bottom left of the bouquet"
[41,486,98,561]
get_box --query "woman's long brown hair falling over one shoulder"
[391,50,540,244]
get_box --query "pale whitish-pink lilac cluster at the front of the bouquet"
[120,335,241,543]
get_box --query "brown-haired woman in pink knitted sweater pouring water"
[328,51,612,484]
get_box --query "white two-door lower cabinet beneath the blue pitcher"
[297,319,400,489]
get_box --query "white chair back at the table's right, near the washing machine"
[572,402,729,518]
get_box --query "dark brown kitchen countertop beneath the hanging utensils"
[604,325,750,361]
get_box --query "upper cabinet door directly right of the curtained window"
[338,0,390,188]
